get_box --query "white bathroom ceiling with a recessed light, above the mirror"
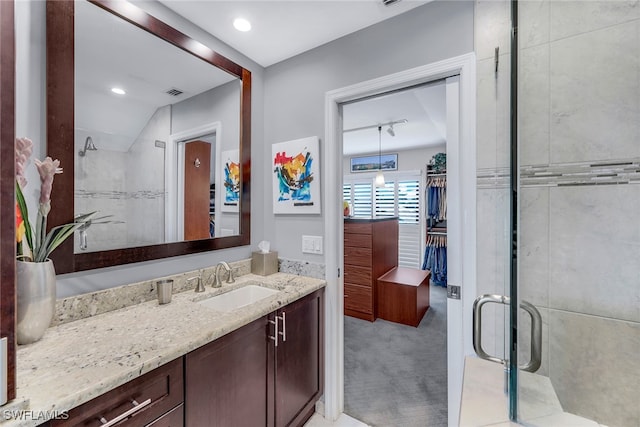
[160,0,432,67]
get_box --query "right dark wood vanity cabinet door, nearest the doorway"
[275,289,324,427]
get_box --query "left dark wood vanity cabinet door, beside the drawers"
[185,317,270,427]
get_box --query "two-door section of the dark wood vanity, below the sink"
[185,290,324,427]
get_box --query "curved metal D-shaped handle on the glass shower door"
[473,295,542,372]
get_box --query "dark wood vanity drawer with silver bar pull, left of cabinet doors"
[51,358,184,427]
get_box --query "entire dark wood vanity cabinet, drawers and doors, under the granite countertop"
[41,289,324,427]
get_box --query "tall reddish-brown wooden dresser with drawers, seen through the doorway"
[344,218,398,322]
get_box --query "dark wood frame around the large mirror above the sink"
[47,0,251,274]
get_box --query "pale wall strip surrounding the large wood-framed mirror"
[16,1,265,297]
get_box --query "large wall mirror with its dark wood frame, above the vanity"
[47,0,251,273]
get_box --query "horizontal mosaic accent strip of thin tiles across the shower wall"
[477,158,640,188]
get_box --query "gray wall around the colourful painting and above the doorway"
[262,1,474,263]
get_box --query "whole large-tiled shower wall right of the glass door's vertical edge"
[519,1,640,426]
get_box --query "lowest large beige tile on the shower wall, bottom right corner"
[549,310,640,427]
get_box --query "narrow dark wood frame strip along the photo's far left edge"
[0,0,16,400]
